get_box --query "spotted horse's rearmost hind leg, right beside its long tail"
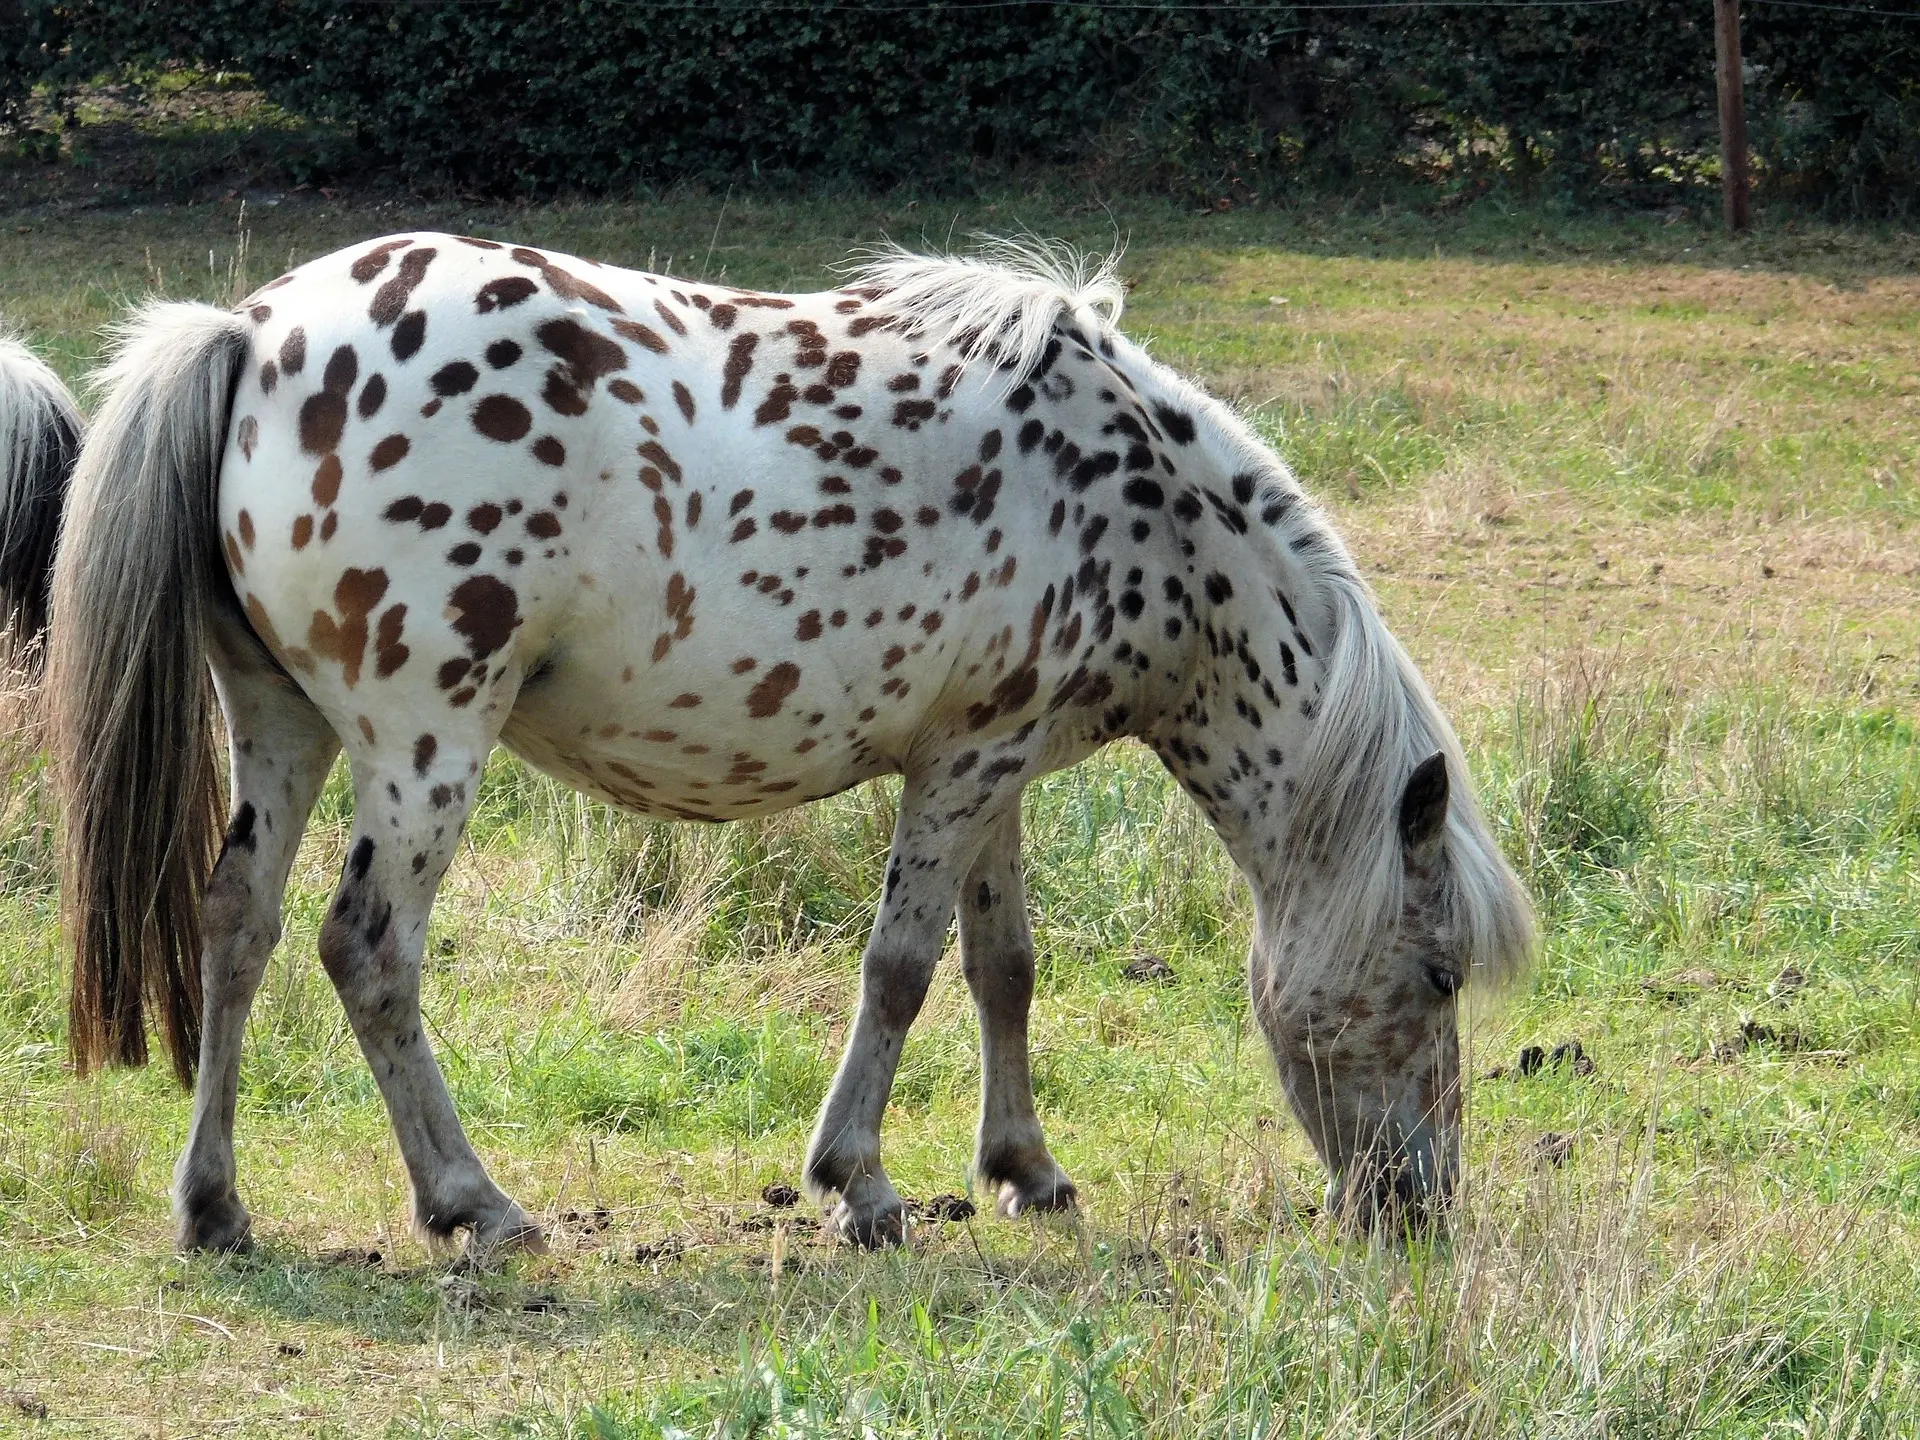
[173,622,340,1250]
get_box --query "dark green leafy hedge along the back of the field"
[0,0,1920,213]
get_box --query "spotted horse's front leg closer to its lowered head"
[958,806,1075,1215]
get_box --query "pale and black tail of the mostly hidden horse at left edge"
[0,334,81,670]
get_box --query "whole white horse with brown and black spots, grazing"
[30,234,1530,1256]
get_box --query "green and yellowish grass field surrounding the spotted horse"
[0,198,1920,1440]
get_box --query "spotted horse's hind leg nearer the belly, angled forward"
[321,733,543,1258]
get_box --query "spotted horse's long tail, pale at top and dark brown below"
[48,301,250,1083]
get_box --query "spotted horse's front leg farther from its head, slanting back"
[804,760,1020,1246]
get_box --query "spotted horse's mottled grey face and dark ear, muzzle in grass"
[1252,755,1473,1229]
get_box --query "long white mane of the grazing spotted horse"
[851,240,1534,998]
